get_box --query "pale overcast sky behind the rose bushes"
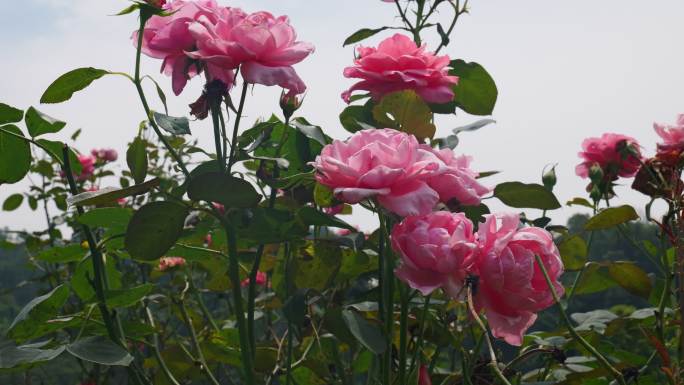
[0,0,684,229]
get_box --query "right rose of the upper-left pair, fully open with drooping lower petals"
[187,8,314,95]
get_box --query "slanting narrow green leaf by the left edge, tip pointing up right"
[7,285,69,340]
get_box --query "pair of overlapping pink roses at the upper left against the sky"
[133,0,314,95]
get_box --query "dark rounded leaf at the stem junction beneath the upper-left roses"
[188,172,261,208]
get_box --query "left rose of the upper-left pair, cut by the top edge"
[132,0,233,95]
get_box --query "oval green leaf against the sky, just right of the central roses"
[494,182,561,210]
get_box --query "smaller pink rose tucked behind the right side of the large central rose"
[428,148,492,206]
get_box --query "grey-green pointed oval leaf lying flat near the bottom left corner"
[66,336,133,366]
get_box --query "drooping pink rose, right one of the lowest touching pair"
[473,214,564,346]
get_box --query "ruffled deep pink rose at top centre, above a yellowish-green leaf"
[342,34,458,103]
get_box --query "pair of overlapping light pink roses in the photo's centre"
[313,128,490,216]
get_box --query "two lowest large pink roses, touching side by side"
[392,211,563,346]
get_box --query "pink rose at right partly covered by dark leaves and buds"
[575,133,641,180]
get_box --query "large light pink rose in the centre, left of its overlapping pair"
[313,128,441,216]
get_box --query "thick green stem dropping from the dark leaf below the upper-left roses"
[223,222,256,385]
